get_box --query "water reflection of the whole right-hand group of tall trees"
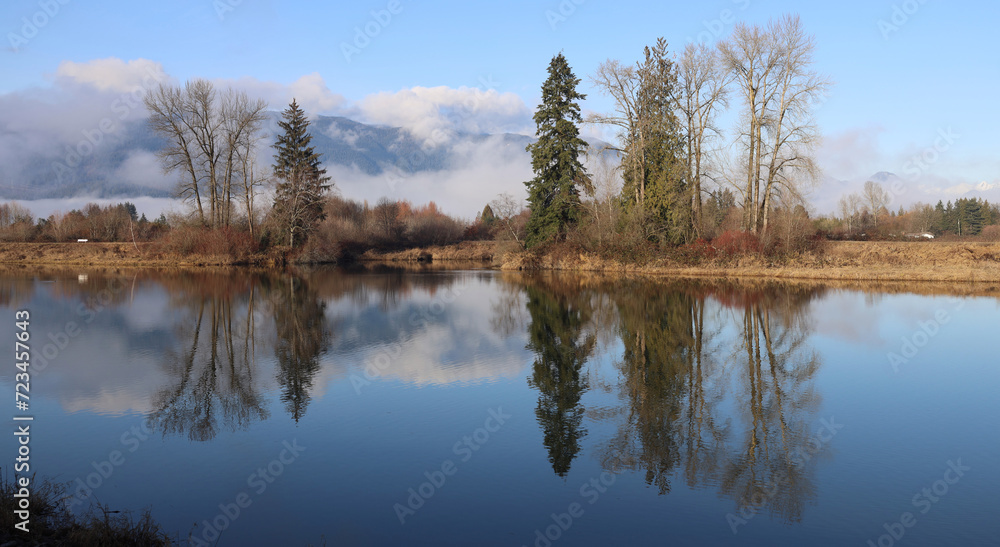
[504,274,822,521]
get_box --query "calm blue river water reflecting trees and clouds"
[0,270,1000,547]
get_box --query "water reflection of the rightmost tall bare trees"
[721,288,820,522]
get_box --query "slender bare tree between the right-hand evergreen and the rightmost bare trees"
[677,44,732,238]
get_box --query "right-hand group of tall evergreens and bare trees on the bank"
[525,16,830,252]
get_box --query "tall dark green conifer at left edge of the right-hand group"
[525,53,590,247]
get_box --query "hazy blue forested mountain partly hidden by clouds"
[0,112,606,200]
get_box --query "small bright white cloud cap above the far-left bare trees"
[56,57,168,93]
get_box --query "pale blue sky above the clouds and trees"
[0,0,1000,214]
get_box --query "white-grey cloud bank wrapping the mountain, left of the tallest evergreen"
[0,58,534,215]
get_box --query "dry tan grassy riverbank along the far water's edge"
[0,241,1000,283]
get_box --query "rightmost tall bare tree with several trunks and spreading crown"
[719,16,830,232]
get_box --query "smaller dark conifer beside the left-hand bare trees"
[272,99,332,246]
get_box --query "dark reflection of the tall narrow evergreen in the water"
[527,280,595,476]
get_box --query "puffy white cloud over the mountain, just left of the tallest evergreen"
[358,86,531,145]
